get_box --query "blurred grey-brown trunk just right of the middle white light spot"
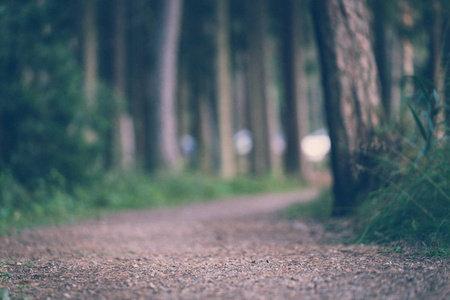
[246,0,270,175]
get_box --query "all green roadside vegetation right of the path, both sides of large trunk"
[284,78,450,255]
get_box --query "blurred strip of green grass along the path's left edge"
[0,173,301,235]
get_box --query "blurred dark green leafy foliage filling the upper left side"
[0,0,97,188]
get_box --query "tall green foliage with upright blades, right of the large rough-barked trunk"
[359,80,450,249]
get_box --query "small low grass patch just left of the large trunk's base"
[283,190,333,219]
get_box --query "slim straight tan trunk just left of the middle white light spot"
[217,0,236,178]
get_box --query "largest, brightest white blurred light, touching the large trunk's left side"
[301,129,331,162]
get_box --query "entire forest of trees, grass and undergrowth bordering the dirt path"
[0,0,450,247]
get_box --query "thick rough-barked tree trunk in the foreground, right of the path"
[312,0,380,215]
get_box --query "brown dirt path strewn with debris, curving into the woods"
[0,190,450,299]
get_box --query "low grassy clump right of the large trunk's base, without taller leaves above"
[359,148,450,247]
